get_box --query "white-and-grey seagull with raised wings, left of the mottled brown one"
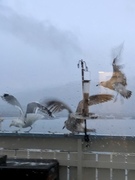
[1,94,52,132]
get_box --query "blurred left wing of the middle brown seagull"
[44,99,73,113]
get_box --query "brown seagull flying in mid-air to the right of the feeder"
[96,56,132,101]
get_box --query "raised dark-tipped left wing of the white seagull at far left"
[1,94,24,115]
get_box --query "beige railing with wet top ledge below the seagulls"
[0,133,135,180]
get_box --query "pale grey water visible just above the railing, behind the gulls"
[0,117,135,136]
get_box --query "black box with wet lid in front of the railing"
[0,158,59,180]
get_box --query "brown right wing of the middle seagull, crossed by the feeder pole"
[76,94,114,113]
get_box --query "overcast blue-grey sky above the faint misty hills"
[0,0,135,93]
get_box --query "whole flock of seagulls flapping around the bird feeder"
[1,53,132,134]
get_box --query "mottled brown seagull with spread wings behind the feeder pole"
[44,94,114,134]
